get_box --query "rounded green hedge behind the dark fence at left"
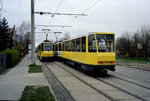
[0,49,20,66]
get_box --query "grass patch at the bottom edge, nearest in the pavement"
[20,86,55,101]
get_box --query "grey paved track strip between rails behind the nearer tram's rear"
[95,74,150,101]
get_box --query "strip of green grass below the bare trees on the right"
[116,56,150,64]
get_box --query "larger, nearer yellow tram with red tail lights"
[55,32,116,71]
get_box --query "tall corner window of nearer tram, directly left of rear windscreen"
[88,34,96,52]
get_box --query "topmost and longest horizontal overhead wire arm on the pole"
[34,12,88,16]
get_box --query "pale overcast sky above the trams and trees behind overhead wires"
[1,0,150,46]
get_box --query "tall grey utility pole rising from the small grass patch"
[31,0,36,65]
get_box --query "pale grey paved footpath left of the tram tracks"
[0,55,48,100]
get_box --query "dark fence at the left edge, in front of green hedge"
[0,53,8,73]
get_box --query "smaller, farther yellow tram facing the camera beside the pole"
[37,42,55,60]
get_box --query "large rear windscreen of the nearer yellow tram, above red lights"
[96,34,114,52]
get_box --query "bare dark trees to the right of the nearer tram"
[116,26,150,59]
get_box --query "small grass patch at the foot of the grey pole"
[28,65,43,73]
